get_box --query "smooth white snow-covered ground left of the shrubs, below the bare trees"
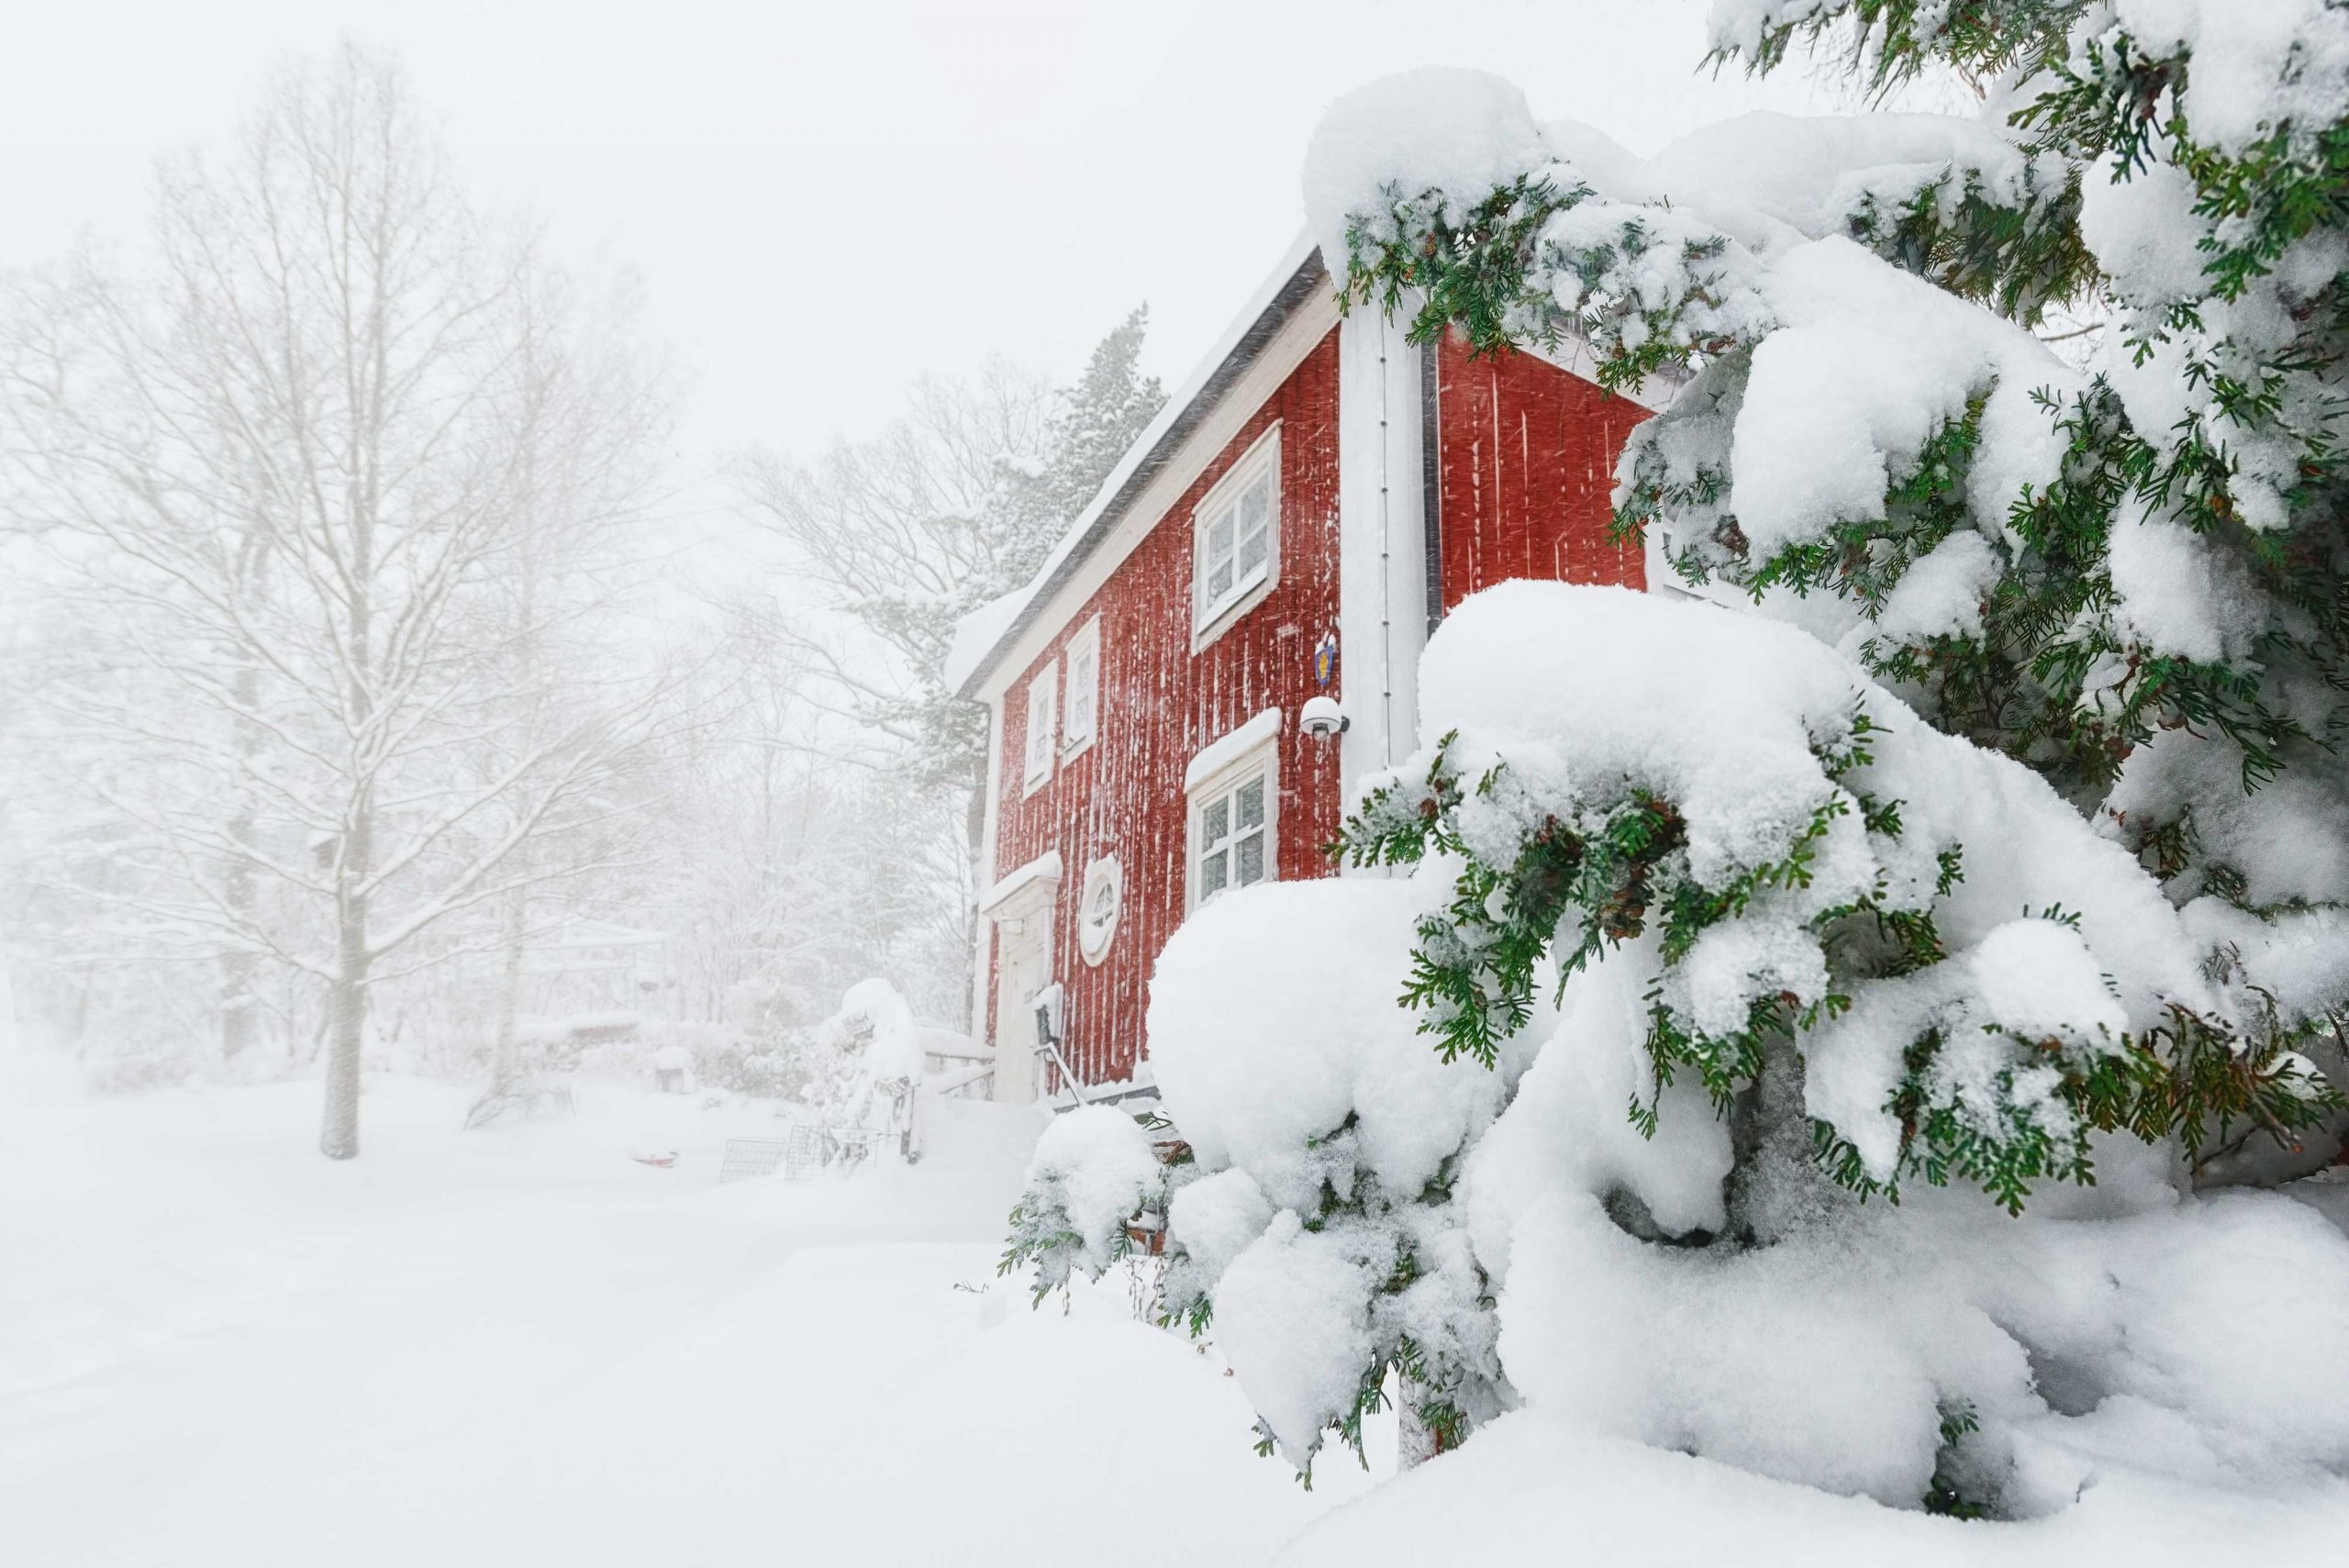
[0,1054,1367,1568]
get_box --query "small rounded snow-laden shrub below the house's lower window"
[1149,883,1539,1464]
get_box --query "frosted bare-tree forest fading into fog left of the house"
[0,45,1161,1155]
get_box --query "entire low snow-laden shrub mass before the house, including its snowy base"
[1042,584,2349,1514]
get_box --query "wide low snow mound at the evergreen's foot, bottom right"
[1501,1193,2349,1517]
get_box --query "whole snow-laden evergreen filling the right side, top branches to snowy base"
[1024,0,2349,1514]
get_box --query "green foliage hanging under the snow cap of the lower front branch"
[1339,711,2342,1214]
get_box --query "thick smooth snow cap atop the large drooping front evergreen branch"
[1402,582,2224,1029]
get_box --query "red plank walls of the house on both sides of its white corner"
[982,331,1647,1089]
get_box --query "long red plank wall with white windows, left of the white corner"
[986,331,1343,1082]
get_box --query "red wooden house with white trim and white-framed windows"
[953,244,1649,1098]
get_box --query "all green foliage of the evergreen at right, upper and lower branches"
[1343,0,2349,1239]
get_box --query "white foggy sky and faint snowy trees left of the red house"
[0,0,1816,1127]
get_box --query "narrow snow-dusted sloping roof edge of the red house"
[944,232,1330,697]
